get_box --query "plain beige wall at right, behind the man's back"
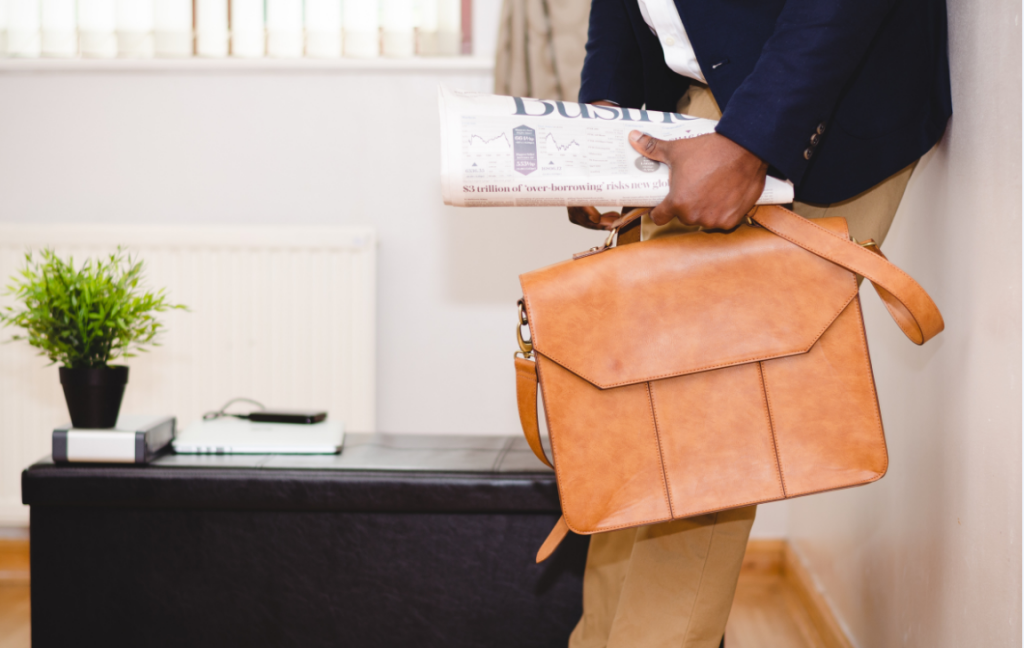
[790,0,1021,648]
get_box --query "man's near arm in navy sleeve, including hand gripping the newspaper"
[630,0,890,229]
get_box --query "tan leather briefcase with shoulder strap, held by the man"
[515,206,943,562]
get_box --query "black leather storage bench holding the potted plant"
[22,434,587,648]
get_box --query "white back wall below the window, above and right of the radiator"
[0,61,784,536]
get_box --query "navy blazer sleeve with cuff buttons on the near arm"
[716,0,891,184]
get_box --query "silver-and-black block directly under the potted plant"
[53,415,176,464]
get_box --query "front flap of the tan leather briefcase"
[519,218,857,389]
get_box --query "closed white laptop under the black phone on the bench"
[173,417,345,455]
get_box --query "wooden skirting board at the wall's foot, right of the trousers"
[741,539,854,648]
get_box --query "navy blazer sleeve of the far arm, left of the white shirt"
[580,0,644,107]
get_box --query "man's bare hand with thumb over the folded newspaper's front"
[630,131,768,229]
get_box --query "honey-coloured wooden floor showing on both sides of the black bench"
[0,541,837,648]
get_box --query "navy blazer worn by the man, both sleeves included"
[580,0,952,203]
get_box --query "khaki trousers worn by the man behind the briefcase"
[569,84,916,648]
